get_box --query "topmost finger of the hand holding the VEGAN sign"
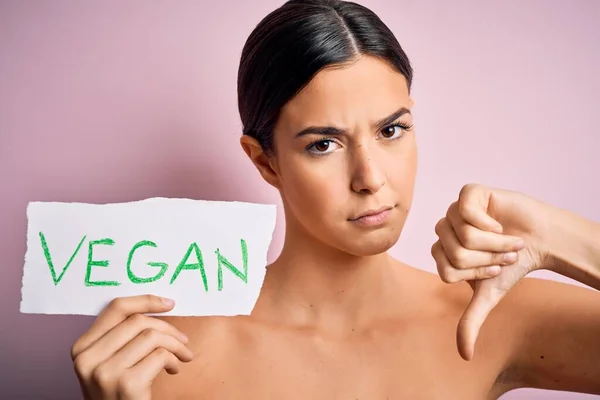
[71,295,174,360]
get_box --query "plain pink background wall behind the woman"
[0,0,600,399]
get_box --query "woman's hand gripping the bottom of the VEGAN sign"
[71,295,193,400]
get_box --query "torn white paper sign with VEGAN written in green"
[21,198,276,316]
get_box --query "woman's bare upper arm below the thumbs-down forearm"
[505,278,600,394]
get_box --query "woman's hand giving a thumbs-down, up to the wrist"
[431,184,548,360]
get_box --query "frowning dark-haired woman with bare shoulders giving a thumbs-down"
[72,0,600,400]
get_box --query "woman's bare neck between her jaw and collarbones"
[253,225,406,336]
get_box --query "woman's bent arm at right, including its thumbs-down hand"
[432,185,600,394]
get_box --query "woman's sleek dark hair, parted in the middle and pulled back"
[237,0,412,153]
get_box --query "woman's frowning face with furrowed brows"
[246,57,417,256]
